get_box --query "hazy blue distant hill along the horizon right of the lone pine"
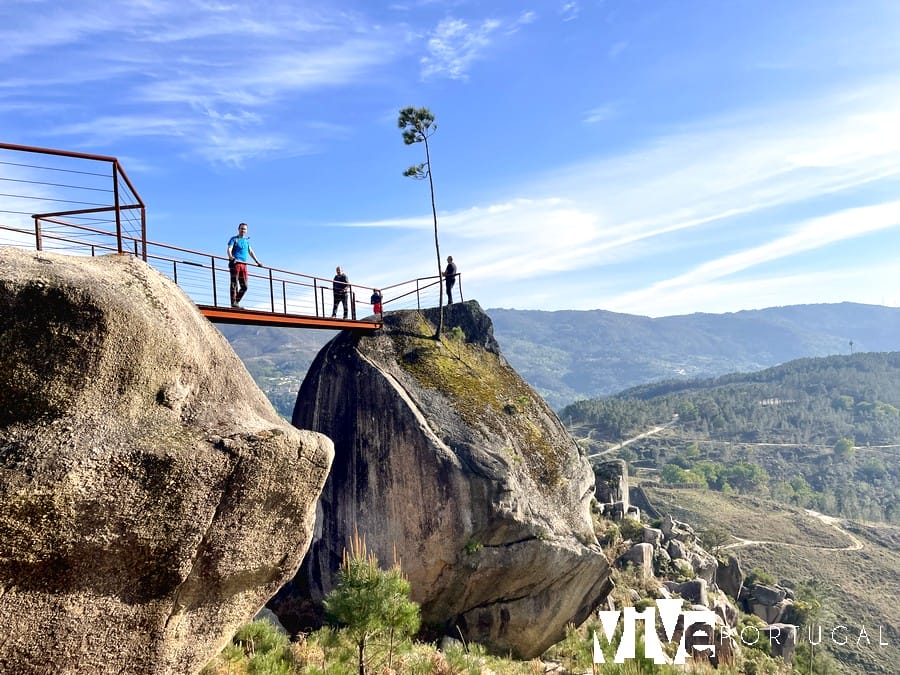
[487,302,900,409]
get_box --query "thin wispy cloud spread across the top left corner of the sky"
[0,0,402,164]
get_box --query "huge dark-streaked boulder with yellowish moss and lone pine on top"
[269,302,610,658]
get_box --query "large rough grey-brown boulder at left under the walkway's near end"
[0,247,333,674]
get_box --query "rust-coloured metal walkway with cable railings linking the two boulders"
[0,143,462,331]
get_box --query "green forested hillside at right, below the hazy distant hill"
[561,352,900,522]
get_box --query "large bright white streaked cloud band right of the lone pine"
[334,76,900,313]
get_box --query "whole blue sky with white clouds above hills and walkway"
[0,0,900,316]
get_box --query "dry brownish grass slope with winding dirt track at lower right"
[645,487,900,674]
